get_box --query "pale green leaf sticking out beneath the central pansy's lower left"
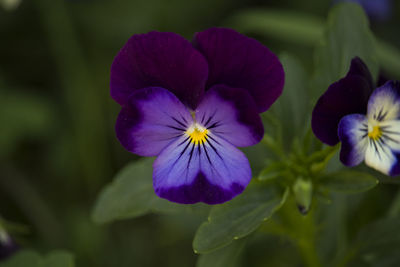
[92,158,184,223]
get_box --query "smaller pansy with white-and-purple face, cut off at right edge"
[312,58,400,176]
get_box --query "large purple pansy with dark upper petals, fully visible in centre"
[111,28,284,204]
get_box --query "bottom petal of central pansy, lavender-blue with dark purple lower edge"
[153,134,251,204]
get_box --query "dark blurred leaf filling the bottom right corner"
[345,217,400,267]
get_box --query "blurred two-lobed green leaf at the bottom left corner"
[0,250,75,267]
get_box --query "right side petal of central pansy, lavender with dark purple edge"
[195,85,264,147]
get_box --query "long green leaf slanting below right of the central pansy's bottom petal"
[193,183,287,253]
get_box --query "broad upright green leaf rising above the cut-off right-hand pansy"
[314,3,379,97]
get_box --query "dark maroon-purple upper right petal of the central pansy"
[193,28,284,112]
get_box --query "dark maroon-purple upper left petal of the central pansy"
[110,32,208,108]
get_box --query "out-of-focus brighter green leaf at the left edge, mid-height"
[0,88,54,157]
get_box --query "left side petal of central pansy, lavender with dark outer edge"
[115,87,193,157]
